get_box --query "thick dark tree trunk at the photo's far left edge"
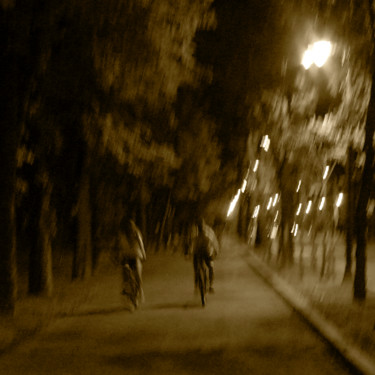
[0,6,21,314]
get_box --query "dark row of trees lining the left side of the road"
[0,0,247,312]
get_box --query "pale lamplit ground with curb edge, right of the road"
[234,237,375,374]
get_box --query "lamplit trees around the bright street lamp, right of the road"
[236,1,375,301]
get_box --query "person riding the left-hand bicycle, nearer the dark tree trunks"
[118,219,146,302]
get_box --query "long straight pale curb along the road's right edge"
[246,254,375,375]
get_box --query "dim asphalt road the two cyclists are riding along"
[0,236,356,375]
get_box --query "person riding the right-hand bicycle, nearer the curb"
[192,218,219,293]
